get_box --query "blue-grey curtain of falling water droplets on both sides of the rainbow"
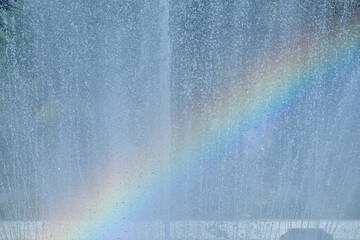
[0,0,360,219]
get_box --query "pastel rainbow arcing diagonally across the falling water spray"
[39,19,360,240]
